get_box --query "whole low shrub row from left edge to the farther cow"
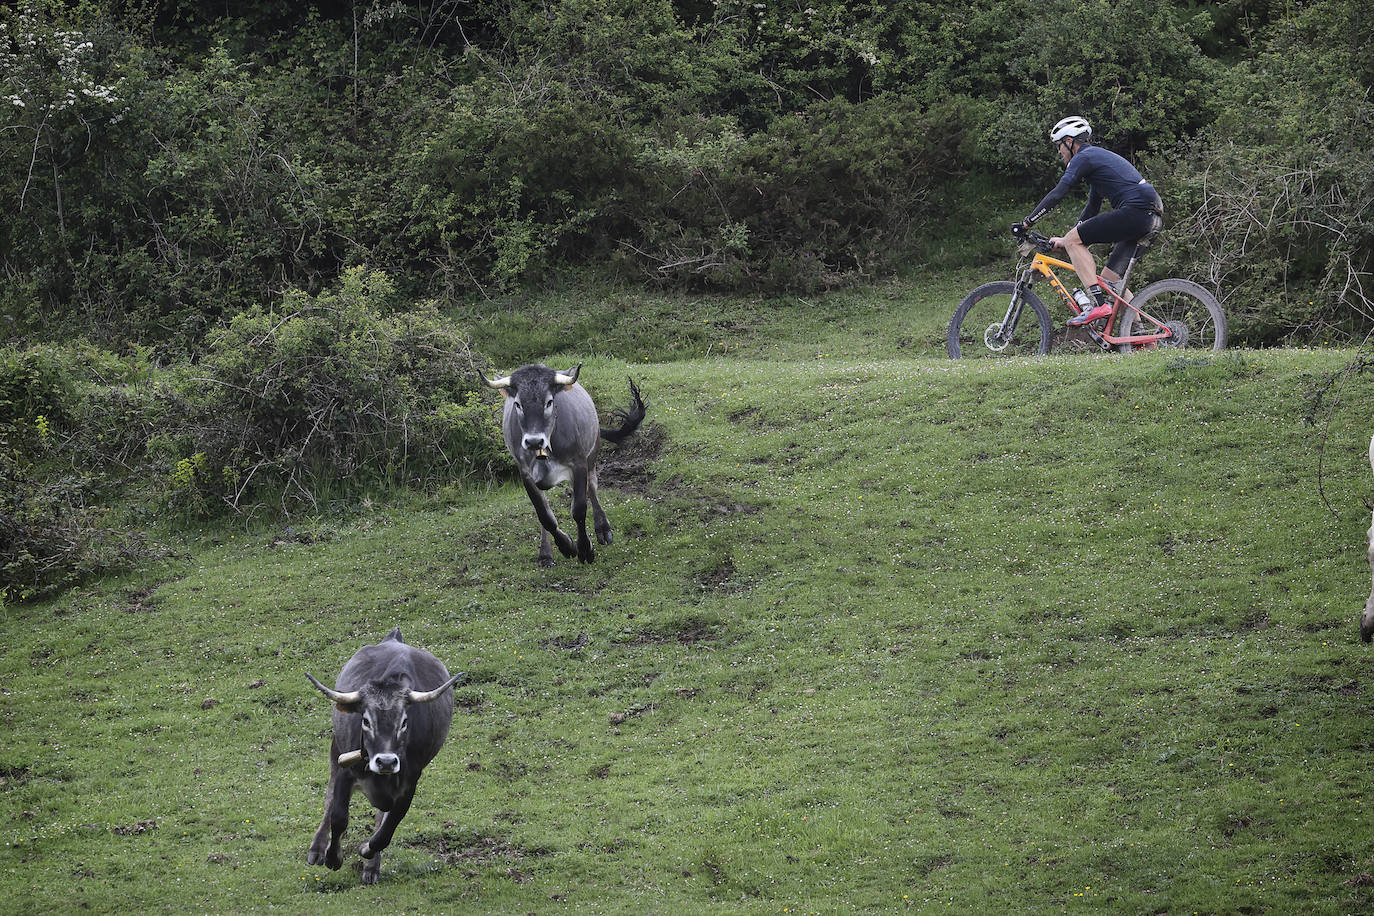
[0,287,508,602]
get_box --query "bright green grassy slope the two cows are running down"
[0,339,1374,913]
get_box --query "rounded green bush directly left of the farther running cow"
[150,269,503,514]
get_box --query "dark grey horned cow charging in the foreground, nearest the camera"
[305,628,463,884]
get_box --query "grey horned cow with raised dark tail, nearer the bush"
[482,364,646,566]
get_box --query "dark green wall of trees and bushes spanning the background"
[0,0,1374,358]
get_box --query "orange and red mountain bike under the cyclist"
[945,225,1226,360]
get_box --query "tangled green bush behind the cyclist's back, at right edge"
[1151,1,1374,343]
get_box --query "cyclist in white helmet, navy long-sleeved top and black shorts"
[1021,117,1164,324]
